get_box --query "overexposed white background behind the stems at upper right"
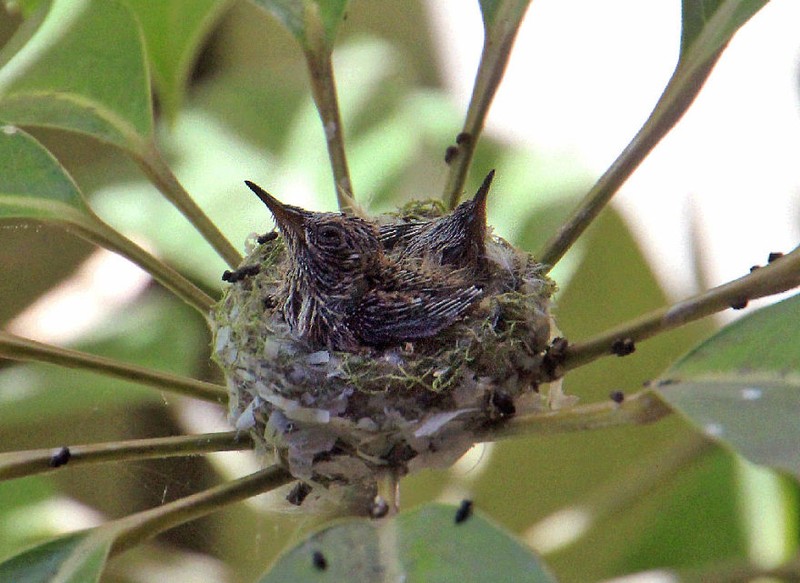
[428,0,800,306]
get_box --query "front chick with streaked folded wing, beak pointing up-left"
[245,181,482,351]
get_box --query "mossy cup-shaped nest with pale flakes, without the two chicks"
[213,203,555,503]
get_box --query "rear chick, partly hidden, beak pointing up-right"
[380,170,494,273]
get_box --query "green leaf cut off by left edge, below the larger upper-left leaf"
[0,125,90,222]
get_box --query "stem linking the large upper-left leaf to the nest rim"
[134,141,242,269]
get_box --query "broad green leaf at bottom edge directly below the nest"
[261,504,554,583]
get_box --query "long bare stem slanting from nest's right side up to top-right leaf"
[536,47,724,267]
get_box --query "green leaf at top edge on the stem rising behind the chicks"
[253,0,348,52]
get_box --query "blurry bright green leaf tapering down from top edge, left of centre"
[128,0,231,120]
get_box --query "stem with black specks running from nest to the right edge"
[564,247,800,370]
